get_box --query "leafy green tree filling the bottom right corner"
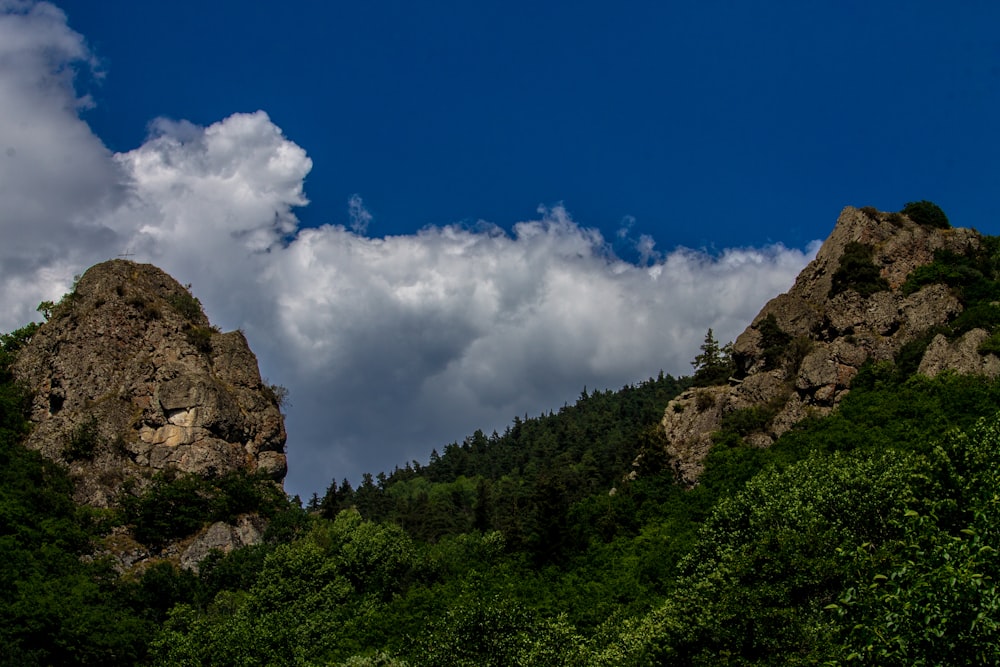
[830,417,1000,666]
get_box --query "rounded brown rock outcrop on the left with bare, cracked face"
[15,260,286,507]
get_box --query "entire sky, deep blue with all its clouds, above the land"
[0,0,1000,497]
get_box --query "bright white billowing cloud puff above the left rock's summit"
[115,111,312,260]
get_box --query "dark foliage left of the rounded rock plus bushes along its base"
[0,325,300,667]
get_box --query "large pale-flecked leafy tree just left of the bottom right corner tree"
[599,452,914,666]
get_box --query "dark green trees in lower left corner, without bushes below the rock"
[0,327,149,666]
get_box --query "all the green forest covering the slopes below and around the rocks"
[0,211,1000,667]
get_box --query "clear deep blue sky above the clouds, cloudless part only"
[54,0,1000,248]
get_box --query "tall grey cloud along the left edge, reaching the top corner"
[0,1,125,323]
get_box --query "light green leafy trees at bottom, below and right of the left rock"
[153,510,415,665]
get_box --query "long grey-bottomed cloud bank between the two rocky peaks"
[250,207,814,496]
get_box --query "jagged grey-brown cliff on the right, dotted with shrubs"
[663,207,1000,485]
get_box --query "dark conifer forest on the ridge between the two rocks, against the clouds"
[310,374,688,565]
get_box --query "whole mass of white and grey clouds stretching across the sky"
[0,0,815,495]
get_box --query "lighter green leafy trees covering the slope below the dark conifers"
[127,365,1000,665]
